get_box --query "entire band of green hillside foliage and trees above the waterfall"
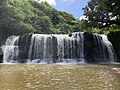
[0,0,120,35]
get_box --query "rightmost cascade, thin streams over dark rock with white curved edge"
[93,33,115,63]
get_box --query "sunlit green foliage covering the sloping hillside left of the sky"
[0,0,81,34]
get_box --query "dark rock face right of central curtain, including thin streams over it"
[84,33,110,63]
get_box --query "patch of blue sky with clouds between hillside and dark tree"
[35,0,89,19]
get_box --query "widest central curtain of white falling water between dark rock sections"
[28,32,84,63]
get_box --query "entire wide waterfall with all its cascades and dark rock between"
[2,32,115,63]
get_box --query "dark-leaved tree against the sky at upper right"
[83,0,120,28]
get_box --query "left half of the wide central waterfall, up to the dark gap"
[28,34,53,63]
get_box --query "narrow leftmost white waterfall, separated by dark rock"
[2,36,19,63]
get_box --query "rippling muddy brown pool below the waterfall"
[0,64,120,90]
